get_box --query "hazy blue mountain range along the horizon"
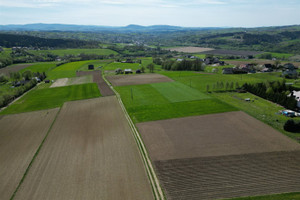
[0,23,222,32]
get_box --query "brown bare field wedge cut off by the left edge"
[0,108,58,200]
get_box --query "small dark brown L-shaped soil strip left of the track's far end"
[76,71,115,96]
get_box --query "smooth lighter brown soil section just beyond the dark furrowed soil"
[137,111,300,160]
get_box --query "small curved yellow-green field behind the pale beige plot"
[47,60,98,79]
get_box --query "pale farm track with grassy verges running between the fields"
[102,73,165,200]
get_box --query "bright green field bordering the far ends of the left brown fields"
[0,83,101,115]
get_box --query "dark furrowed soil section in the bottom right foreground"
[154,151,300,199]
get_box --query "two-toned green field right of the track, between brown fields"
[115,82,237,122]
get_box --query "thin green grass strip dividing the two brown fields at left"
[10,107,62,200]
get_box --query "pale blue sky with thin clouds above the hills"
[0,0,300,27]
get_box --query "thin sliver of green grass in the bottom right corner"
[227,192,300,200]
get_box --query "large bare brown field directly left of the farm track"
[15,96,154,200]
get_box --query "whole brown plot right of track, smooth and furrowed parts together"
[137,111,300,199]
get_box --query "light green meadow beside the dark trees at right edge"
[212,92,300,142]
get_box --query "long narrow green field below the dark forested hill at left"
[29,49,118,56]
